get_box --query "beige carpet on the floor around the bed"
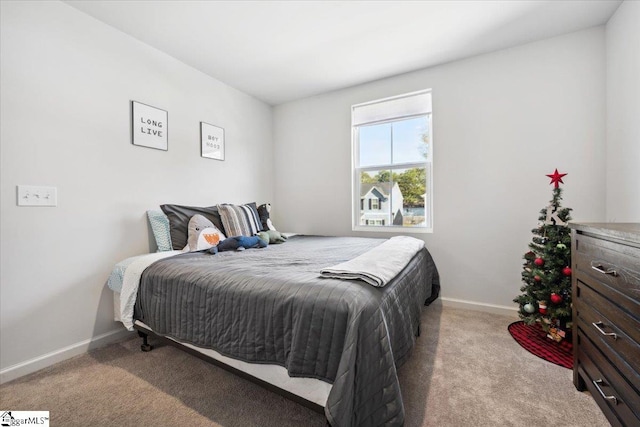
[0,302,609,427]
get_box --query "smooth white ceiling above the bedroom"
[66,0,622,105]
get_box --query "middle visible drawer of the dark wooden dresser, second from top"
[574,283,640,390]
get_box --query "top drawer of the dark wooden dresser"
[573,235,640,304]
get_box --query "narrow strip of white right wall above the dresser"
[606,0,640,222]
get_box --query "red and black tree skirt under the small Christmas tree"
[508,321,573,369]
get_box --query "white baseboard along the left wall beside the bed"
[0,329,132,384]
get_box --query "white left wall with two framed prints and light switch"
[0,1,273,380]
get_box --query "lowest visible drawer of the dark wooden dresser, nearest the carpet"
[578,329,640,426]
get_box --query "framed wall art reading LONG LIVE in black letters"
[131,101,169,151]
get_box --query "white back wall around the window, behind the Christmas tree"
[273,27,606,307]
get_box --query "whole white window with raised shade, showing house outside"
[351,90,433,231]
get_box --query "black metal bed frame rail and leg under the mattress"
[133,324,329,416]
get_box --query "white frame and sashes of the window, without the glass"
[351,89,434,233]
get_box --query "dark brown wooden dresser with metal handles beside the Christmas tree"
[570,223,640,426]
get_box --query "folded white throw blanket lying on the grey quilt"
[320,236,424,288]
